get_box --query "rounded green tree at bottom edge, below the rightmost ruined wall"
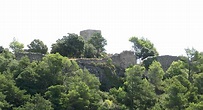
[165,75,191,110]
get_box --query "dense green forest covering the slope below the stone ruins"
[0,35,203,110]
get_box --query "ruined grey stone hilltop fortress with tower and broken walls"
[15,29,180,71]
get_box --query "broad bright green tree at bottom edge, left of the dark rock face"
[45,70,102,110]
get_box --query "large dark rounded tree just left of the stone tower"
[51,33,84,58]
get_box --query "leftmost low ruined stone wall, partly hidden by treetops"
[15,52,44,61]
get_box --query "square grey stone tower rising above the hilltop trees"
[80,29,101,41]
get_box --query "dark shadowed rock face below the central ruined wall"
[76,60,125,91]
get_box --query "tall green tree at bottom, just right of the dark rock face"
[125,65,156,110]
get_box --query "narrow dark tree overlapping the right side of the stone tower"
[89,33,107,58]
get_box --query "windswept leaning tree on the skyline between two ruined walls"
[129,37,158,60]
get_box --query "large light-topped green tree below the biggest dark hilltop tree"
[35,53,76,94]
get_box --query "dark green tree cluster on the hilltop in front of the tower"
[51,33,107,58]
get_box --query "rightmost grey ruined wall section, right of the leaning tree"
[156,55,180,71]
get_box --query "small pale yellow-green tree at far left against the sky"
[9,38,24,53]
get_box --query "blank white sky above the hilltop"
[0,0,203,55]
